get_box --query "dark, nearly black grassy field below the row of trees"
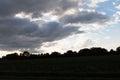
[0,55,120,80]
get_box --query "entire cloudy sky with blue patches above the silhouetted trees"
[0,0,120,56]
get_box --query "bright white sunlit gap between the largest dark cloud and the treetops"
[41,33,94,53]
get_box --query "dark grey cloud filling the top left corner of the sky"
[0,0,56,17]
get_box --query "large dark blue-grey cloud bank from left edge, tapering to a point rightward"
[0,18,81,50]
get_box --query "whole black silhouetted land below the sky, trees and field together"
[0,47,120,80]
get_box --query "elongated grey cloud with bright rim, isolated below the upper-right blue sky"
[60,11,110,24]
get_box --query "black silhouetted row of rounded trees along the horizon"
[1,47,120,60]
